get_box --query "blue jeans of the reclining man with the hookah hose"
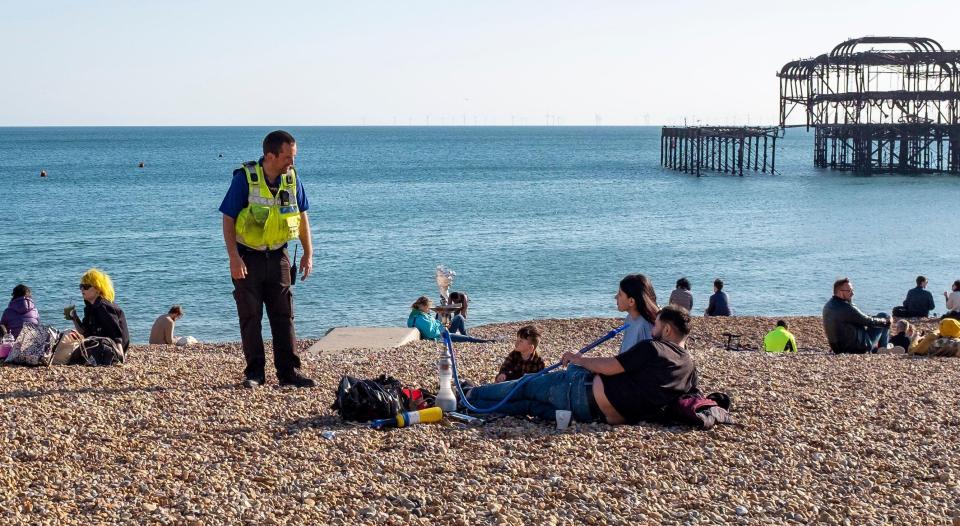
[467,365,594,422]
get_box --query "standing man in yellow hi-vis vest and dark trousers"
[220,130,316,388]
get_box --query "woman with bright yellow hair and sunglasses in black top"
[69,268,130,352]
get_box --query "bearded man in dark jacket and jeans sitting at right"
[823,278,890,354]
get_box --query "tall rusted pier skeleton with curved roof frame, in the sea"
[777,37,960,174]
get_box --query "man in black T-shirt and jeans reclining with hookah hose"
[467,305,698,424]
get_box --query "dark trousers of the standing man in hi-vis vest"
[233,246,300,379]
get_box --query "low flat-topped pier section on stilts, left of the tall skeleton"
[660,126,780,177]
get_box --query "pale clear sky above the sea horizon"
[0,0,960,126]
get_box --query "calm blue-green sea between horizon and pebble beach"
[0,126,960,343]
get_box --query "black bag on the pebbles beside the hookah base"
[331,374,407,422]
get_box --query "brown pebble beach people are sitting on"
[0,317,960,525]
